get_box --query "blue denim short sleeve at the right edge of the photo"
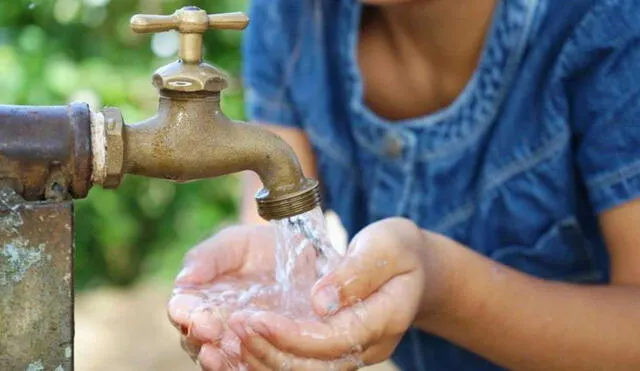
[571,0,640,213]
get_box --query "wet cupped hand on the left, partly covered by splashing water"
[168,226,275,370]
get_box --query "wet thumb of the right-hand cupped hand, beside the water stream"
[311,219,420,316]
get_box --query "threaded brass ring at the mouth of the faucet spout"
[256,179,320,220]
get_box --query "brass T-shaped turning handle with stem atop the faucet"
[130,6,249,64]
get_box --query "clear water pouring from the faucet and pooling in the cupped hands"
[170,208,356,369]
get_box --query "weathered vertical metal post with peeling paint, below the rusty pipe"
[0,189,74,371]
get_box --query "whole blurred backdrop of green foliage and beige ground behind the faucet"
[0,0,396,371]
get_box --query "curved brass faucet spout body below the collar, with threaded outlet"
[123,91,319,220]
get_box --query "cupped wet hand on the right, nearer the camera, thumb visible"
[230,219,447,370]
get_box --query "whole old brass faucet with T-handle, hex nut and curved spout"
[91,7,319,220]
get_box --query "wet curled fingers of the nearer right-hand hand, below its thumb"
[230,274,420,360]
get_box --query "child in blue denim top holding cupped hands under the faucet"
[169,0,640,370]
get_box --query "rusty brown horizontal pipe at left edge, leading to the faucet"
[0,103,92,201]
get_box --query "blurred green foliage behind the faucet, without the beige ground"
[0,0,246,289]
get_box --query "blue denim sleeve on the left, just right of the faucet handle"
[243,0,300,127]
